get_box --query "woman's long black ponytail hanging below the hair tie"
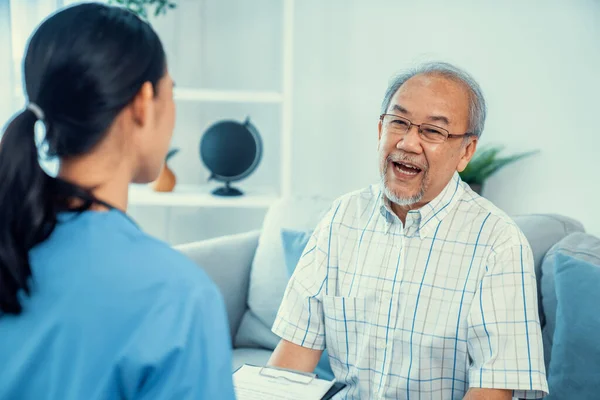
[0,109,94,315]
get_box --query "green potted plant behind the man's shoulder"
[460,146,537,194]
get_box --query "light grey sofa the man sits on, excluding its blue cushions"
[177,198,596,394]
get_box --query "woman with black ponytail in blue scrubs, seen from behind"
[0,3,234,400]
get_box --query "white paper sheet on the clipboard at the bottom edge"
[233,365,335,400]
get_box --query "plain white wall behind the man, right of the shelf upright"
[292,0,600,235]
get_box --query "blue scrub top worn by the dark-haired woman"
[0,210,234,400]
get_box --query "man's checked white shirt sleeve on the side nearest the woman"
[272,205,339,350]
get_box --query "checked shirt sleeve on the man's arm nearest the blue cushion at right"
[467,232,548,399]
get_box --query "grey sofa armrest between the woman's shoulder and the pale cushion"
[175,231,260,338]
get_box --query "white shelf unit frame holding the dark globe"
[129,0,294,208]
